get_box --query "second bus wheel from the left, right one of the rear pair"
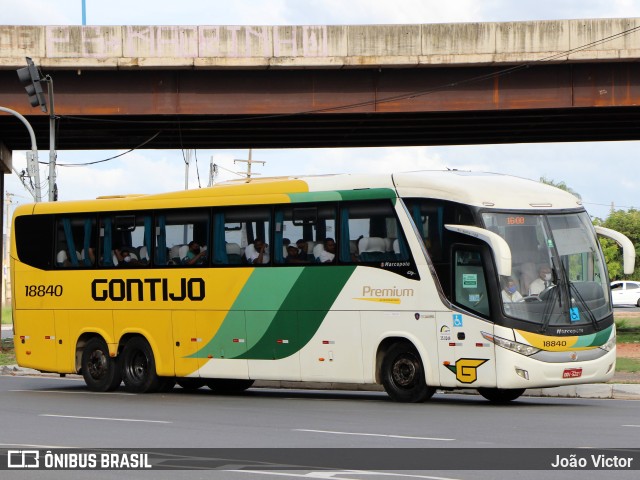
[120,337,162,393]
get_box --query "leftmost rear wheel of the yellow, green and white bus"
[81,337,122,392]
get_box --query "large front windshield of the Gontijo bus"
[482,212,611,331]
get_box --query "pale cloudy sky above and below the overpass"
[0,0,640,218]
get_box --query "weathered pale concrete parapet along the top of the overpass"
[0,18,640,69]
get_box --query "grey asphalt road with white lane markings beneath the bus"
[0,376,640,480]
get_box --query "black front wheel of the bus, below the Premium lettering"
[380,342,436,403]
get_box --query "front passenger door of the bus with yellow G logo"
[437,245,496,388]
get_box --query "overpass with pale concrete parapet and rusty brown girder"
[0,18,640,166]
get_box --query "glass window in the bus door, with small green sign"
[453,246,490,317]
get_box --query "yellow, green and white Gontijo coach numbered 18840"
[11,171,634,402]
